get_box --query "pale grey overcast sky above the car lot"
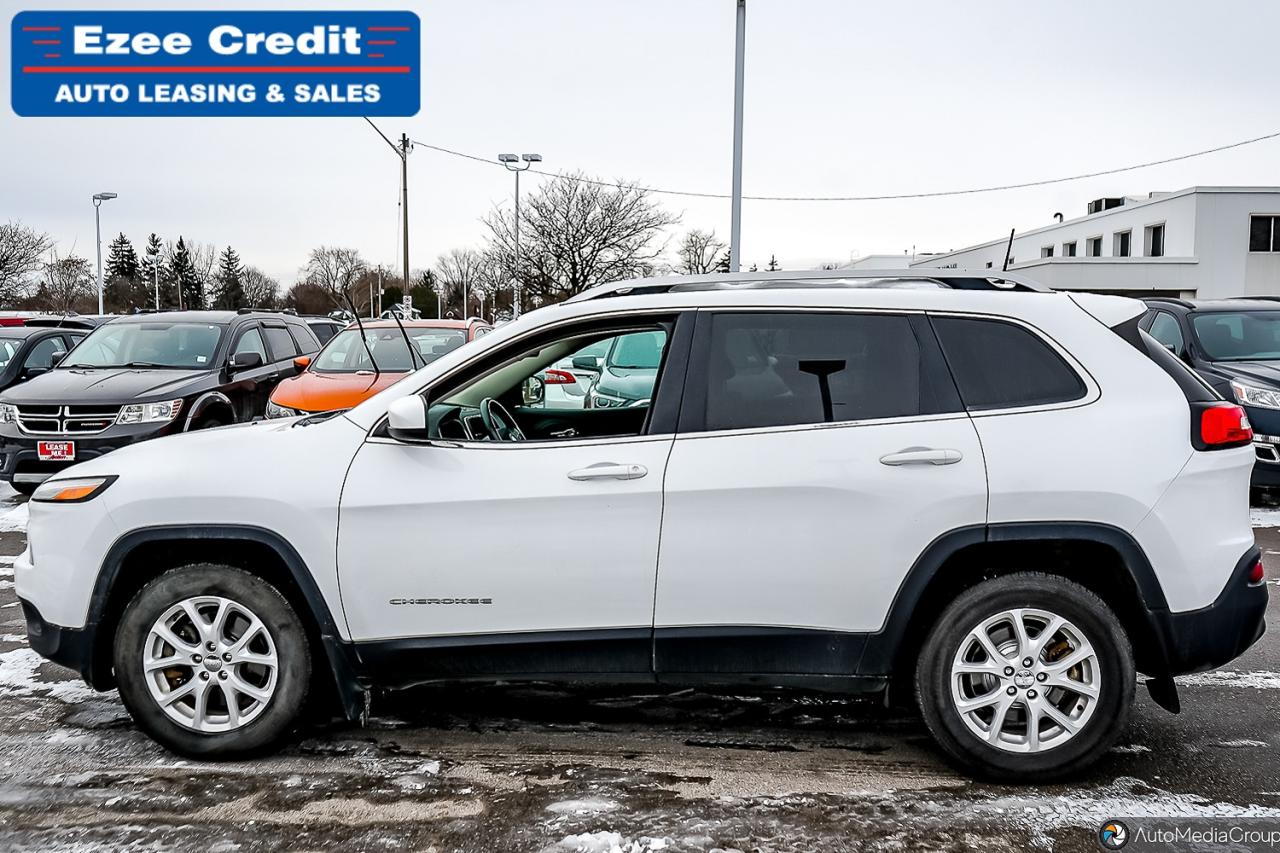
[0,0,1280,286]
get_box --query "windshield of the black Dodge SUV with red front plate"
[61,320,223,368]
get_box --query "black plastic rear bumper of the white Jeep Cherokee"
[1152,547,1268,675]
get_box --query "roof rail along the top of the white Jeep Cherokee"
[564,268,1051,302]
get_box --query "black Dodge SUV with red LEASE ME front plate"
[0,311,320,494]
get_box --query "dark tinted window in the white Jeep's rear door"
[700,311,959,430]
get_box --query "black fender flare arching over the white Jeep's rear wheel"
[858,521,1169,676]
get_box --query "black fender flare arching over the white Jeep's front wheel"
[84,525,369,720]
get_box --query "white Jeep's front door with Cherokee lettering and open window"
[338,312,680,680]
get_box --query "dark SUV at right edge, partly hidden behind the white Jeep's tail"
[1139,298,1280,488]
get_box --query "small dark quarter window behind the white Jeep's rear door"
[933,316,1085,410]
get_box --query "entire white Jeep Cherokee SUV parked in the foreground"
[15,270,1267,780]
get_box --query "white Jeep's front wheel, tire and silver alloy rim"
[114,564,311,760]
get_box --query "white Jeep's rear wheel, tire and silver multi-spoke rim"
[915,573,1135,781]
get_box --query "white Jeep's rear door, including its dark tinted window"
[654,310,987,676]
